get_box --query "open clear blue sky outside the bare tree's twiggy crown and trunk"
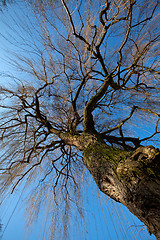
[0,1,158,240]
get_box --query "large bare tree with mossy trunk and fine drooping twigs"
[0,0,160,239]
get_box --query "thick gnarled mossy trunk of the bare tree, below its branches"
[83,134,160,239]
